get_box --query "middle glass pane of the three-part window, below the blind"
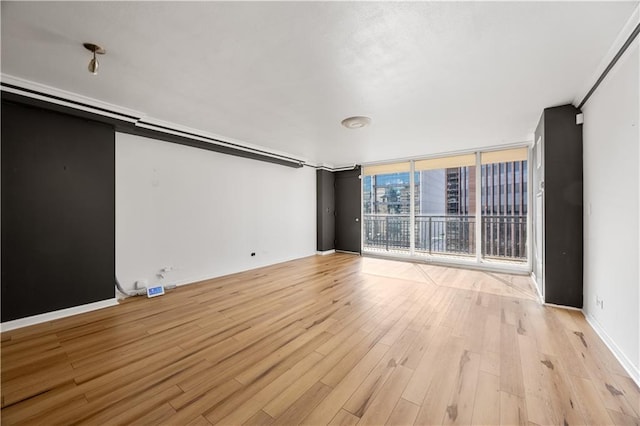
[415,166,476,256]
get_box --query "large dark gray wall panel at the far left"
[1,100,115,322]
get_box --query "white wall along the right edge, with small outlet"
[583,40,640,382]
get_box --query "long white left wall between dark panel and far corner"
[116,133,316,289]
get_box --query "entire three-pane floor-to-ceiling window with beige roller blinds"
[362,147,528,272]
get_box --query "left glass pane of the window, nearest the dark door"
[363,171,411,252]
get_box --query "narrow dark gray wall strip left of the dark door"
[316,169,336,251]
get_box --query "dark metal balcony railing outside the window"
[363,214,527,260]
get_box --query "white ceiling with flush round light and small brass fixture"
[1,1,638,166]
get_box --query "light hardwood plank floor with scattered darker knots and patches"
[1,254,640,425]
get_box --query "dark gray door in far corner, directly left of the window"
[335,167,362,253]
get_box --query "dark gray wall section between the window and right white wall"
[535,105,583,308]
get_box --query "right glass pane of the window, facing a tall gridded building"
[480,156,528,262]
